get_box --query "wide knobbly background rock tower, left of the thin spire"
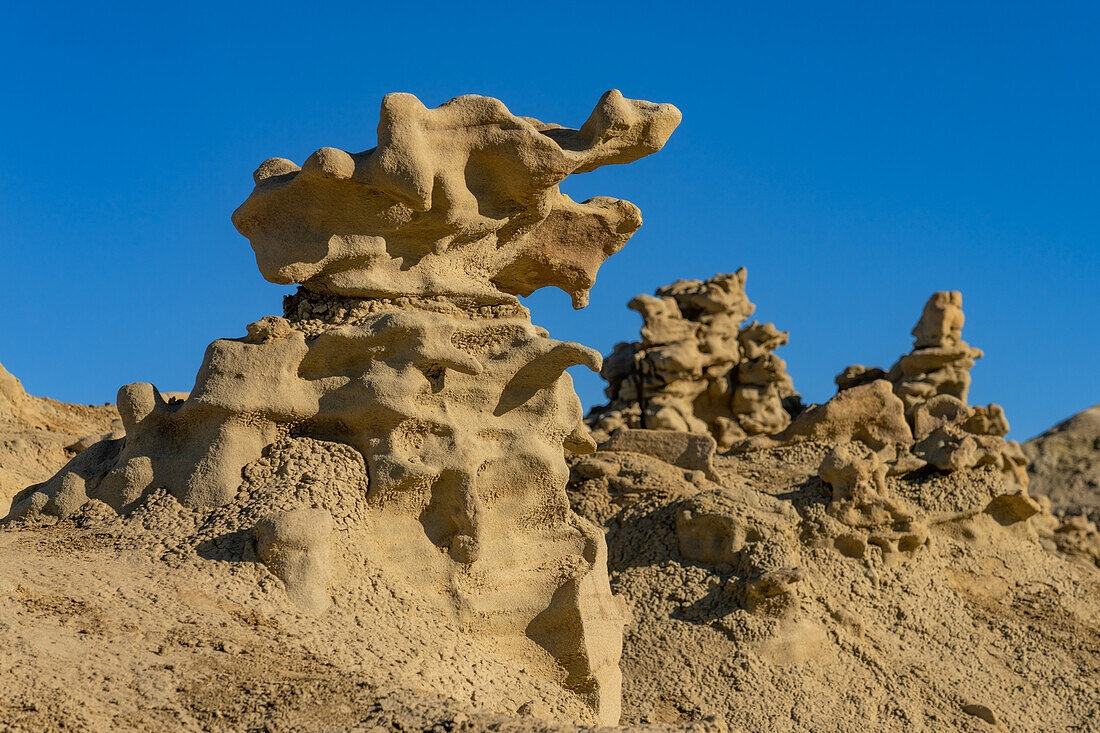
[586,267,801,449]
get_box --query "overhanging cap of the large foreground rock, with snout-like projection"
[233,89,680,308]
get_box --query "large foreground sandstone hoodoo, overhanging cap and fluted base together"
[11,91,677,723]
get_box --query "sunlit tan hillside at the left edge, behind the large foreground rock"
[0,364,122,515]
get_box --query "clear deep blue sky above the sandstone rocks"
[0,2,1100,439]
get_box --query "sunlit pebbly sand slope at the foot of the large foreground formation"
[0,460,591,731]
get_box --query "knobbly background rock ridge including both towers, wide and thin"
[585,281,1027,489]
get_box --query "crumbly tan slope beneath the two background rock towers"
[571,440,1100,731]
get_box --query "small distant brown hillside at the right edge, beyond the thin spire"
[1023,405,1100,522]
